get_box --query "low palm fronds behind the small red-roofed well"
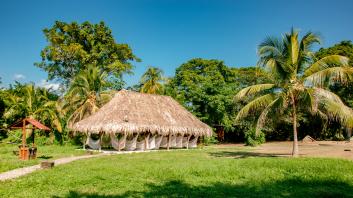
[4,84,62,132]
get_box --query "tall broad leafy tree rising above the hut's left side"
[35,21,139,87]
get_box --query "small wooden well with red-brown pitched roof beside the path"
[10,118,50,160]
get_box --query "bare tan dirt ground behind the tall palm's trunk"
[217,141,353,160]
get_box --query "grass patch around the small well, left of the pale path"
[0,143,85,172]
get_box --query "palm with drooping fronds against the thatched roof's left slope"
[62,65,112,126]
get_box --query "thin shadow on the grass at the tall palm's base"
[209,151,290,158]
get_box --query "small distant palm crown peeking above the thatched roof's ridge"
[140,67,163,94]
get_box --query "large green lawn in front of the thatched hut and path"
[0,147,353,197]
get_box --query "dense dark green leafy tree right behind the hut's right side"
[166,58,270,129]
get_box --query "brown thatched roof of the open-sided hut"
[72,90,212,136]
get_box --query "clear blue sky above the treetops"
[0,0,353,86]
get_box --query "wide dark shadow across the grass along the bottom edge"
[58,179,353,198]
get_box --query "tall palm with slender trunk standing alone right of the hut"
[235,29,353,157]
